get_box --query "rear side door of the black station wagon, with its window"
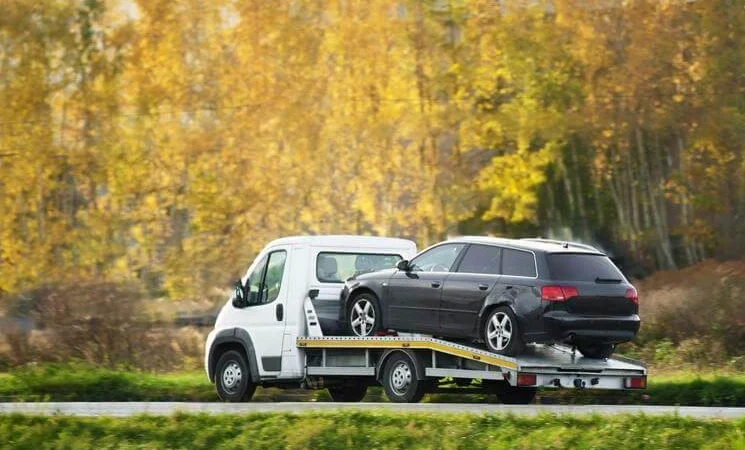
[440,244,501,338]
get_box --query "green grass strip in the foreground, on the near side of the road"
[0,411,745,450]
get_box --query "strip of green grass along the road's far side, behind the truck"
[0,364,745,406]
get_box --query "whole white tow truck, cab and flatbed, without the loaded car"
[205,236,647,404]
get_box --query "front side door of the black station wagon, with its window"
[386,243,465,333]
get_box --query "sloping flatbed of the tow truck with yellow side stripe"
[296,300,647,403]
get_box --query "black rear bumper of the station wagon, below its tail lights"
[543,311,641,344]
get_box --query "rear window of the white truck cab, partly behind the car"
[316,252,402,283]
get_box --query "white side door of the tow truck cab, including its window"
[236,246,290,376]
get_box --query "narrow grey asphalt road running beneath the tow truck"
[0,402,745,419]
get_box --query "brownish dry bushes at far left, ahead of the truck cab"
[0,282,206,370]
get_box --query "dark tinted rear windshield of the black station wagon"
[547,253,624,281]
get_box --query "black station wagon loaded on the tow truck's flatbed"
[340,237,640,358]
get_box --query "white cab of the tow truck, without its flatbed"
[205,236,416,384]
